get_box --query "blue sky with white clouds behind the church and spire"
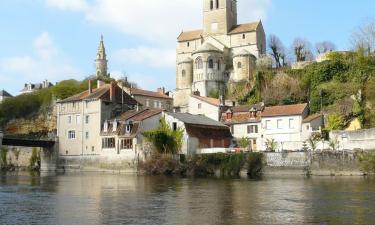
[0,0,375,95]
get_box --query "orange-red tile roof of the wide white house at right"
[262,104,307,117]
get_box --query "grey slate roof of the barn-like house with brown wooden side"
[167,112,227,127]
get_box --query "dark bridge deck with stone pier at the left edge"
[0,131,58,171]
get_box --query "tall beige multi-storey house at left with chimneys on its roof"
[57,81,139,156]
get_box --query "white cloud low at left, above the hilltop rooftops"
[0,32,80,93]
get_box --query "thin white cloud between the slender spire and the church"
[112,46,176,68]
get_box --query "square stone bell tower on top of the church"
[203,0,237,36]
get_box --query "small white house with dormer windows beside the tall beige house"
[100,108,163,158]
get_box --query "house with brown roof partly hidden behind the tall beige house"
[124,88,173,111]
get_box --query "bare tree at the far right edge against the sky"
[352,21,375,54]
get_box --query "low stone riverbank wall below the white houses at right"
[264,152,364,176]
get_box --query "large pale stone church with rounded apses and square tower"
[174,0,266,111]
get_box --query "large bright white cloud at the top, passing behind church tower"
[46,0,271,46]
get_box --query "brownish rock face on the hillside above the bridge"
[4,107,57,134]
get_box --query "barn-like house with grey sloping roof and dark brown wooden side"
[165,112,232,155]
